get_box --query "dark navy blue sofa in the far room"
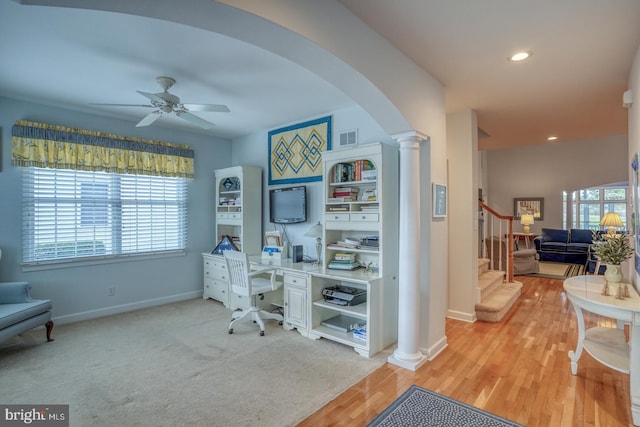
[533,228,593,265]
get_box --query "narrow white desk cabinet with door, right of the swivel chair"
[283,271,309,336]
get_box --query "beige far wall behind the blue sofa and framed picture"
[484,135,629,233]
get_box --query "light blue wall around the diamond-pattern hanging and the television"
[232,107,394,258]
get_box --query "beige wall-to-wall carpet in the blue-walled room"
[0,299,388,426]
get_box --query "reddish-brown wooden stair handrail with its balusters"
[478,200,513,283]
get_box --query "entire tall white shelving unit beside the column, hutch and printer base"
[309,143,398,357]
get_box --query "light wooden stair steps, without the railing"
[475,258,522,322]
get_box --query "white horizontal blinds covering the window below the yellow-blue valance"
[22,168,187,264]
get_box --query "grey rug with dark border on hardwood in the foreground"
[367,385,522,427]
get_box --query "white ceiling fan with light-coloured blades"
[90,77,230,129]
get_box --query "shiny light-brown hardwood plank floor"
[299,276,633,427]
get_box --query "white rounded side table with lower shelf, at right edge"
[563,275,640,426]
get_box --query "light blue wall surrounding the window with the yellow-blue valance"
[0,97,232,323]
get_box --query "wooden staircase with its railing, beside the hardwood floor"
[475,201,522,322]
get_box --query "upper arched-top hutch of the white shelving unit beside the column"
[322,143,399,278]
